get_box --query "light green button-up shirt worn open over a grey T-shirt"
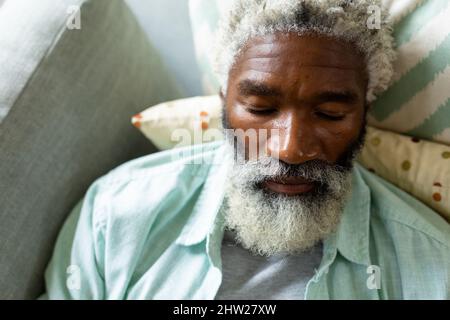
[44,142,450,299]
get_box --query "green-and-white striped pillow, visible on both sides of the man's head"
[190,0,450,145]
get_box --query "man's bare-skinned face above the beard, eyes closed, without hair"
[225,34,367,181]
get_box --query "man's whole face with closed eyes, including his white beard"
[223,34,367,254]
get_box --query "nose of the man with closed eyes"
[267,117,321,164]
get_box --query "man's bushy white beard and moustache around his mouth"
[224,144,351,256]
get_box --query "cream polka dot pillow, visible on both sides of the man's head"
[132,96,450,222]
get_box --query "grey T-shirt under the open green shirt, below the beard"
[215,230,322,300]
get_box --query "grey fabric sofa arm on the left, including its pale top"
[0,0,183,299]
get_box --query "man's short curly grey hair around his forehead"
[215,0,395,103]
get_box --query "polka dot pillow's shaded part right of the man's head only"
[358,127,450,222]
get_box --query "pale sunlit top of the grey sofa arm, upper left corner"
[0,0,85,123]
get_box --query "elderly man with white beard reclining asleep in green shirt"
[46,0,450,299]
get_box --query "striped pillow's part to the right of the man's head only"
[369,0,450,145]
